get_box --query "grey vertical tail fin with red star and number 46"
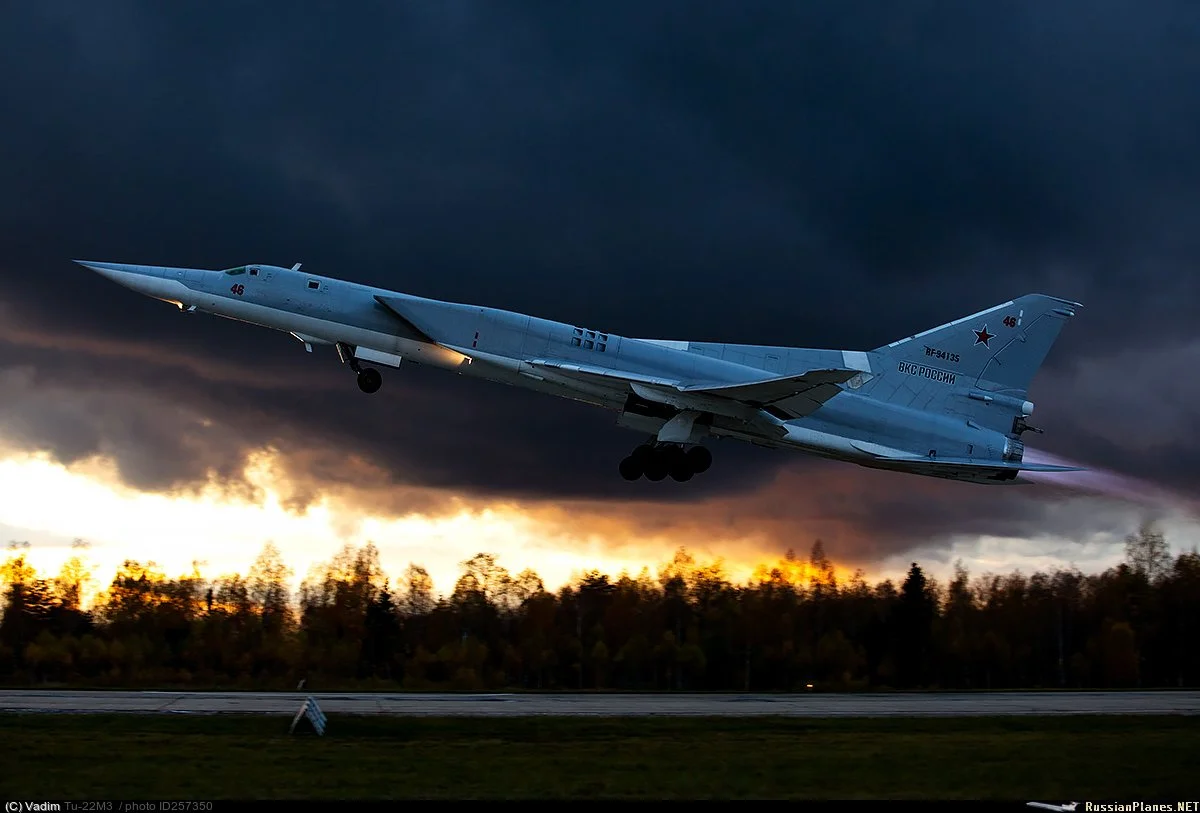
[875,294,1082,397]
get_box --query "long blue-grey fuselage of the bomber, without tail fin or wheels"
[80,261,1084,482]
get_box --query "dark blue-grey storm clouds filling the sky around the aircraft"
[0,0,1200,561]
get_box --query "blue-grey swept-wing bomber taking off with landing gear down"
[74,260,1081,483]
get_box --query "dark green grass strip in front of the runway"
[0,715,1200,801]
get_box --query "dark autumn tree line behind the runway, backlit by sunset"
[0,525,1200,691]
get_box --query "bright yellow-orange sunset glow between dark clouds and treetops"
[0,453,883,604]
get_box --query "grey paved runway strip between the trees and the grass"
[0,689,1200,717]
